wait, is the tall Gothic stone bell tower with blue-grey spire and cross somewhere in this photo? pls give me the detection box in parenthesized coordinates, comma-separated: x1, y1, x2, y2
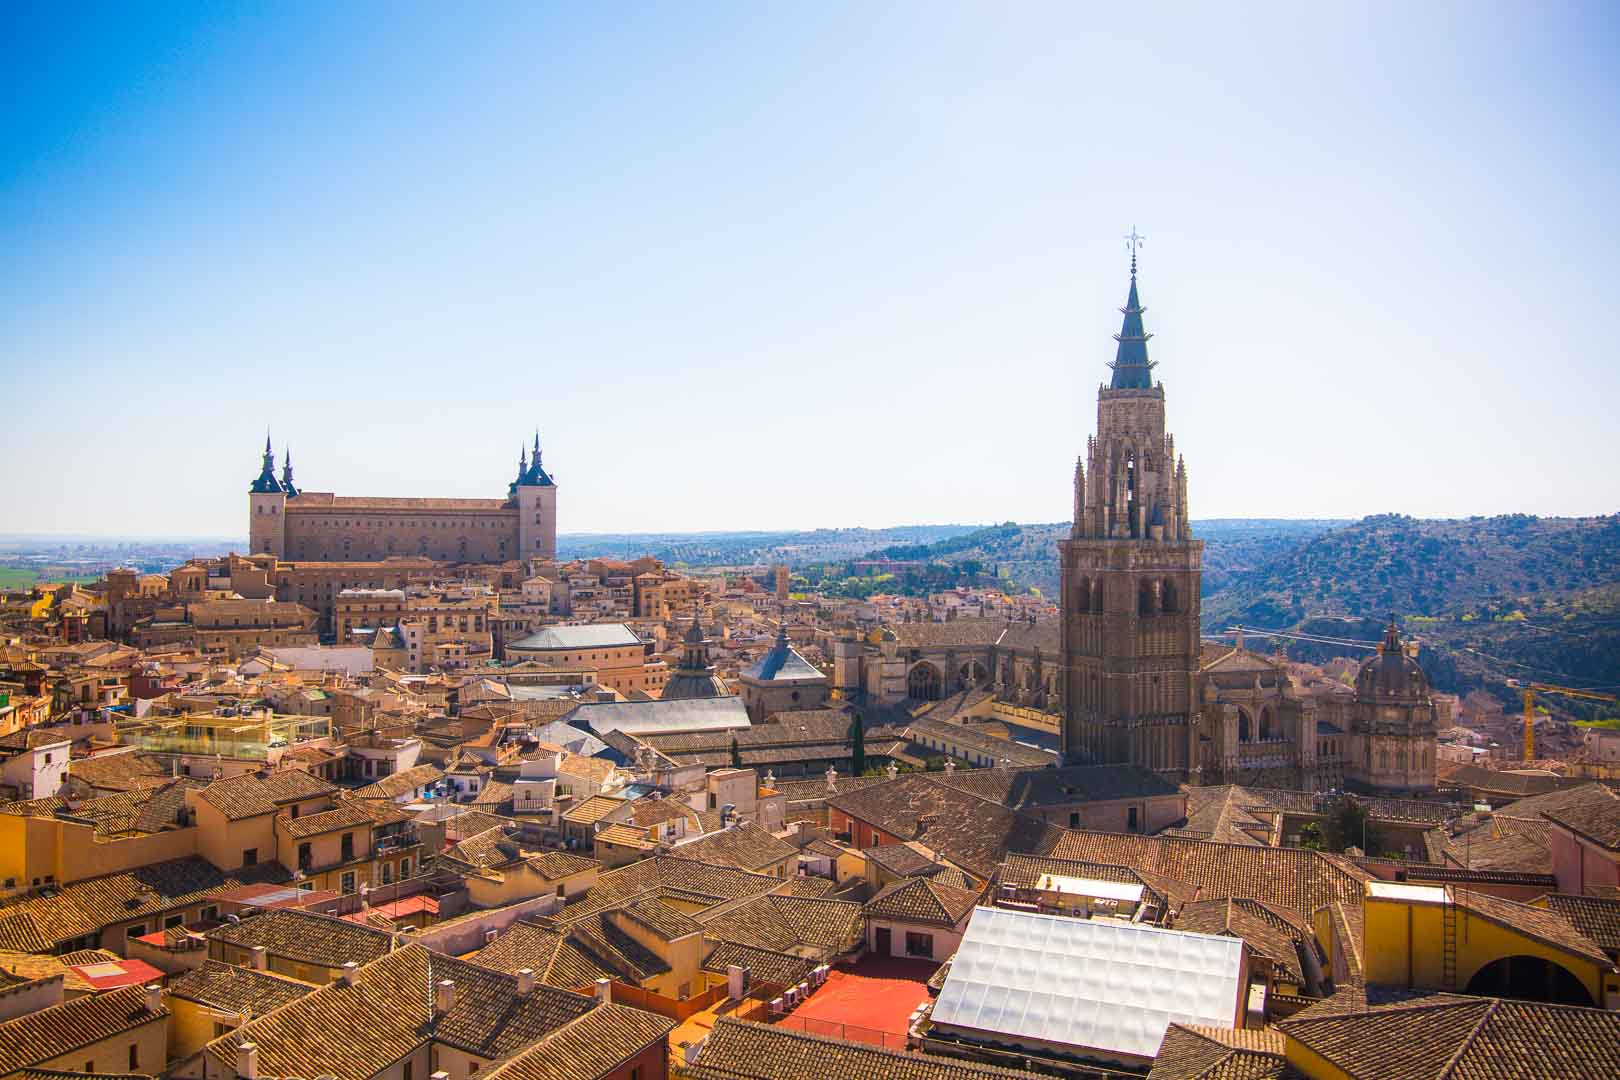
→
(1058, 249, 1204, 779)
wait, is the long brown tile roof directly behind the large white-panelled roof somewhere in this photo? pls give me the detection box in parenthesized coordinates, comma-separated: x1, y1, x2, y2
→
(1051, 829, 1367, 915)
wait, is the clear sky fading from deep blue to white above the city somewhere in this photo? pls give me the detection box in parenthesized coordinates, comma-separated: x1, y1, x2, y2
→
(0, 3, 1620, 534)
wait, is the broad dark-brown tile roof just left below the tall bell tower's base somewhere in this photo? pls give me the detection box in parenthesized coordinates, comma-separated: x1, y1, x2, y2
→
(828, 776, 1069, 879)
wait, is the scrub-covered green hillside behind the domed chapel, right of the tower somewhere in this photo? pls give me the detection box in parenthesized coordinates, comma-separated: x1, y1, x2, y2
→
(1204, 515, 1620, 716)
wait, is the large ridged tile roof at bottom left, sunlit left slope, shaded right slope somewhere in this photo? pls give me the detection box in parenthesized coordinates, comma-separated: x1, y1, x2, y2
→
(204, 944, 596, 1080)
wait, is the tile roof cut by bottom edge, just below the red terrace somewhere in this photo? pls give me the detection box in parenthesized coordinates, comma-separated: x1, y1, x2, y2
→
(693, 1016, 1037, 1080)
